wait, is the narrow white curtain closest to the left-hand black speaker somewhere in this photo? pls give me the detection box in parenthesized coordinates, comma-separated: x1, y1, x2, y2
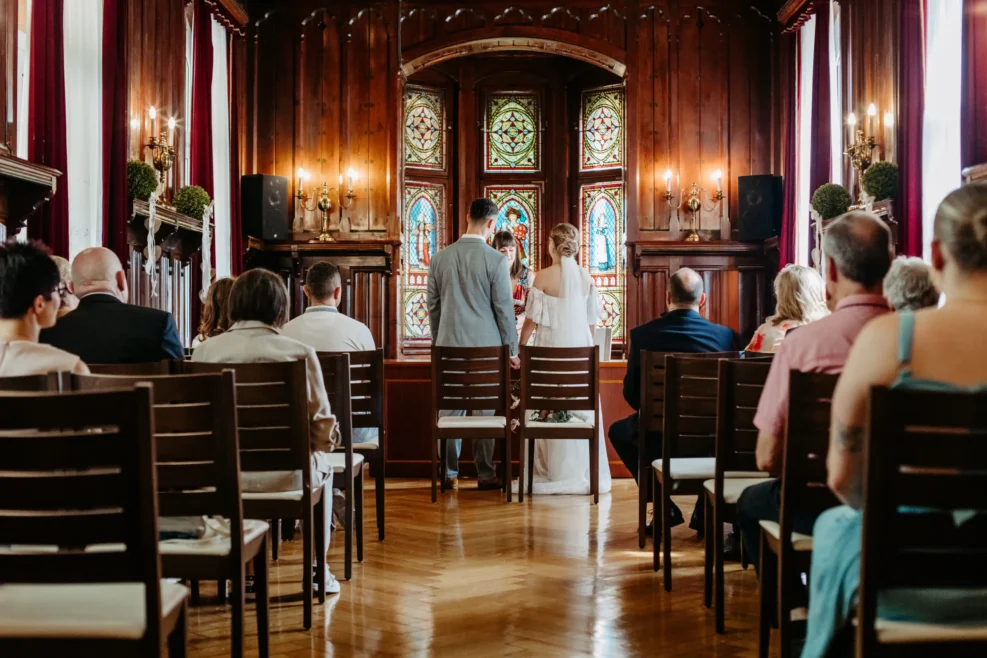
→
(212, 18, 231, 279)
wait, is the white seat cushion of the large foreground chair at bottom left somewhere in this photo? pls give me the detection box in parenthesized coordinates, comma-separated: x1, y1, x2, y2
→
(0, 581, 188, 640)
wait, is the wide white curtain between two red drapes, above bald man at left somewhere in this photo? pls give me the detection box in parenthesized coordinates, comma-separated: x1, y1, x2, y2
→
(64, 0, 103, 259)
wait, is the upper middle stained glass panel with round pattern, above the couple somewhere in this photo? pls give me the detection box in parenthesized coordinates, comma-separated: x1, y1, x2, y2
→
(483, 92, 541, 171)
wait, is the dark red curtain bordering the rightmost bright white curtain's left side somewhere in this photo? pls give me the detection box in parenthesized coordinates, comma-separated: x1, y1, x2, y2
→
(895, 0, 928, 256)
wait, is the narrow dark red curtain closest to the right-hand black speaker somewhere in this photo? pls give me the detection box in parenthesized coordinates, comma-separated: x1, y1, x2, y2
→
(778, 32, 800, 268)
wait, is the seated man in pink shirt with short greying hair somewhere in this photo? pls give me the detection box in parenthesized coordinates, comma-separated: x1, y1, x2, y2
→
(737, 211, 892, 568)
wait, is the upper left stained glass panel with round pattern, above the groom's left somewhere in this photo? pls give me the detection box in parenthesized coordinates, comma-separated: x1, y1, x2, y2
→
(404, 85, 445, 171)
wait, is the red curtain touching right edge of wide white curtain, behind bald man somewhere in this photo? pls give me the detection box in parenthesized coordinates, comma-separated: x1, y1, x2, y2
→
(103, 0, 130, 263)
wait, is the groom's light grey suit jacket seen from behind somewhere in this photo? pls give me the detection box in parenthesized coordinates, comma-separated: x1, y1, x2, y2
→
(428, 237, 518, 356)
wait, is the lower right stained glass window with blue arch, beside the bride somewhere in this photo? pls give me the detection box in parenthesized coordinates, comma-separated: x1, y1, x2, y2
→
(579, 183, 625, 342)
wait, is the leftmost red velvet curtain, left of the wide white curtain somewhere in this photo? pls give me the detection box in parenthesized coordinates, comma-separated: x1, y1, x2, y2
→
(26, 0, 69, 258)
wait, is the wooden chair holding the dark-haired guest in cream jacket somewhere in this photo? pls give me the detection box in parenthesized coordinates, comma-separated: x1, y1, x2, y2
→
(184, 361, 327, 630)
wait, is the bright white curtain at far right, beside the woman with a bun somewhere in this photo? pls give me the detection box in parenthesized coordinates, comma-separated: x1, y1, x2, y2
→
(922, 0, 963, 260)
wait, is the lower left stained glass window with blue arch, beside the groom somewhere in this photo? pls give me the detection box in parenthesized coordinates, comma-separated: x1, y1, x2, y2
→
(401, 181, 446, 342)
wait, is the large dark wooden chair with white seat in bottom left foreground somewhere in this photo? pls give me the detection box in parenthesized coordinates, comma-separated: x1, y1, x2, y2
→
(0, 385, 188, 658)
